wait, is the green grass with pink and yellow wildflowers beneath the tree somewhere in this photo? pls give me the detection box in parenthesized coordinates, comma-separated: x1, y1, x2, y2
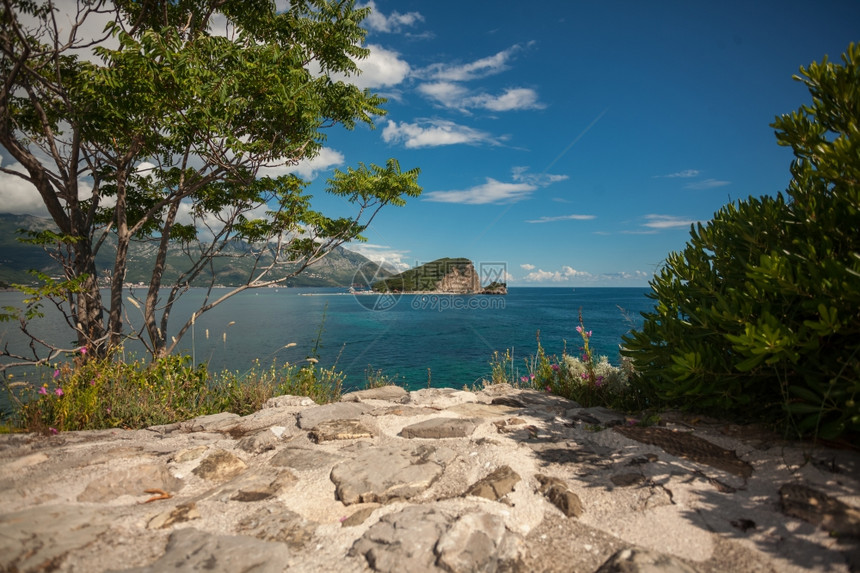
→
(0, 356, 344, 434)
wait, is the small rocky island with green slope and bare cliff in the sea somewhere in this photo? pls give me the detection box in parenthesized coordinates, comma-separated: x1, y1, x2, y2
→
(372, 258, 508, 295)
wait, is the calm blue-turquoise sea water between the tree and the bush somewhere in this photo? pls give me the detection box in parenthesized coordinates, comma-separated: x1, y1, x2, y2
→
(0, 287, 653, 394)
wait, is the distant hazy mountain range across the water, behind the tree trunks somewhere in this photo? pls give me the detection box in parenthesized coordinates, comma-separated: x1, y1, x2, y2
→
(0, 213, 396, 287)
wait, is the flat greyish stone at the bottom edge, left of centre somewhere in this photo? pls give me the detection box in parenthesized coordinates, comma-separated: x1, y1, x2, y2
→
(114, 527, 290, 573)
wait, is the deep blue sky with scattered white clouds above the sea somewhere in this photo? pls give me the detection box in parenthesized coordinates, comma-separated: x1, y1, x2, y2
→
(0, 0, 860, 287)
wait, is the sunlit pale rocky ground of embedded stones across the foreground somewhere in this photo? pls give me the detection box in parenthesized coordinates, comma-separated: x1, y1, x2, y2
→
(0, 385, 860, 573)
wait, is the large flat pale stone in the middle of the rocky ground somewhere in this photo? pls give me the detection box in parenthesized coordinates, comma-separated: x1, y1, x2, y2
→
(331, 444, 454, 505)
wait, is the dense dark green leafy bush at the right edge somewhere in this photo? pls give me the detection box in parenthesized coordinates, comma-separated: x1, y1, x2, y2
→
(622, 44, 860, 438)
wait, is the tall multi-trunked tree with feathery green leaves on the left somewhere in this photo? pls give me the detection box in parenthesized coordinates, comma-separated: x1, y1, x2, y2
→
(0, 0, 421, 366)
